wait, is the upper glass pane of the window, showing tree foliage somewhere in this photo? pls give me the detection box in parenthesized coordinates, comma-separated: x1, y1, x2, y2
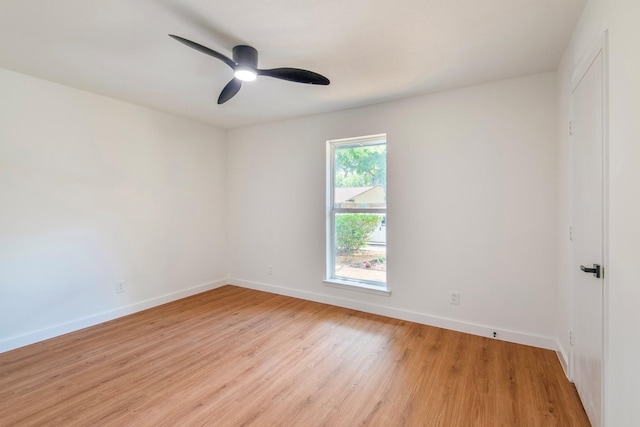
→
(333, 144, 387, 208)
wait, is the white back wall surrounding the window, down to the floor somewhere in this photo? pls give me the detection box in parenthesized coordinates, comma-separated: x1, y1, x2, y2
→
(228, 73, 558, 348)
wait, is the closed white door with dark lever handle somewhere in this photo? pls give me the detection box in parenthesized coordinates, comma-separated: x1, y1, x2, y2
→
(570, 45, 604, 427)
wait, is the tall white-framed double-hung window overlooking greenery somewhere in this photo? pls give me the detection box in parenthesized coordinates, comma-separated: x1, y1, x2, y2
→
(327, 135, 387, 291)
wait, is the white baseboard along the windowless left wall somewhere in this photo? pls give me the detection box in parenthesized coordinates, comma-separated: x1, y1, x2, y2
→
(0, 279, 228, 353)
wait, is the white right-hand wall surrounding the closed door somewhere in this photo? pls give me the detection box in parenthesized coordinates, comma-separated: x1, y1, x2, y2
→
(558, 0, 640, 426)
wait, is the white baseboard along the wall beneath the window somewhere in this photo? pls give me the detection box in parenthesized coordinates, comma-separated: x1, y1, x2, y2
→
(228, 277, 558, 351)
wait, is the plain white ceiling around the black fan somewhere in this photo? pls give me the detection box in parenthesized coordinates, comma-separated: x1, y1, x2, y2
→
(0, 0, 586, 129)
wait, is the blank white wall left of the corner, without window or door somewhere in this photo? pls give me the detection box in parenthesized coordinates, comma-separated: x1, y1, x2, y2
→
(0, 69, 227, 351)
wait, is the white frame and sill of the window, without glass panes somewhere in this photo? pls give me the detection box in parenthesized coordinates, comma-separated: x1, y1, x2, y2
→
(324, 134, 391, 296)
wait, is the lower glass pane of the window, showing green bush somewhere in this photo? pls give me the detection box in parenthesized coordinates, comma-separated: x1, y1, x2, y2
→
(334, 213, 387, 284)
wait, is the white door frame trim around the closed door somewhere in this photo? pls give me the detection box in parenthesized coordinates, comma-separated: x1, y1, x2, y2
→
(568, 30, 610, 426)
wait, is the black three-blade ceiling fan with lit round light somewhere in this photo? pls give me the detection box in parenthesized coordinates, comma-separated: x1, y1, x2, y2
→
(169, 34, 329, 104)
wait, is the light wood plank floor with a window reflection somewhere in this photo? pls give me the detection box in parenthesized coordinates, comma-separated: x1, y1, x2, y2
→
(0, 286, 589, 427)
